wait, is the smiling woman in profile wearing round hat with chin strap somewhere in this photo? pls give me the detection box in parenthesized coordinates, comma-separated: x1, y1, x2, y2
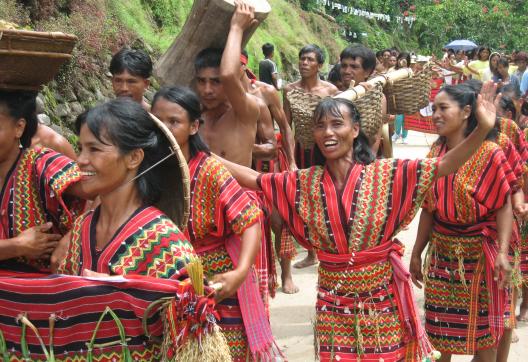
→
(53, 99, 194, 278)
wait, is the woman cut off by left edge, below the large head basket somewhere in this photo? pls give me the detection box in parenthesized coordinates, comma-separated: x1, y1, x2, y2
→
(0, 90, 87, 272)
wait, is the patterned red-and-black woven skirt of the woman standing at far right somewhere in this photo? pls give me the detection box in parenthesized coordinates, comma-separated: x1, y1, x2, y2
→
(424, 232, 512, 354)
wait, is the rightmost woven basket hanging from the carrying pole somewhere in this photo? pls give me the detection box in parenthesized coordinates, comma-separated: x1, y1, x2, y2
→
(384, 65, 433, 114)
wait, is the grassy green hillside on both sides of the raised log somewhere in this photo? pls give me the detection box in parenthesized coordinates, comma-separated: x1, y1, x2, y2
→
(108, 0, 346, 78)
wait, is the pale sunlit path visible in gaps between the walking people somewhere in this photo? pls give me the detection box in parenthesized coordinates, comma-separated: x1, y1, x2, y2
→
(271, 132, 528, 362)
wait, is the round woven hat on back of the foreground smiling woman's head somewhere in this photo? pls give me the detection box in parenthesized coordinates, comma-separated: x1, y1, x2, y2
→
(150, 114, 191, 230)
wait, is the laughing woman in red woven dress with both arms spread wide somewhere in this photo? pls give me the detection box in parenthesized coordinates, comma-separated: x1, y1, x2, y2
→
(218, 82, 495, 361)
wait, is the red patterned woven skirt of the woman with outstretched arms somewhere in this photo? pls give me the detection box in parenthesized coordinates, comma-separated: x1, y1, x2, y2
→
(315, 261, 417, 362)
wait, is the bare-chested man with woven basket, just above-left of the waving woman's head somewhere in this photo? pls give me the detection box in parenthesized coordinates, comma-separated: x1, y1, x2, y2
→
(283, 45, 339, 268)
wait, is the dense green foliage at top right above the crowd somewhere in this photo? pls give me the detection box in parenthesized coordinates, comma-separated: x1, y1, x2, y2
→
(299, 0, 528, 53)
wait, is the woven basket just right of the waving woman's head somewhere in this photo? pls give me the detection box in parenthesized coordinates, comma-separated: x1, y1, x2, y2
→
(354, 83, 383, 138)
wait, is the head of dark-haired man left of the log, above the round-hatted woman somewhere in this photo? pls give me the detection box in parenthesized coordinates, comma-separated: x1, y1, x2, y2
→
(110, 48, 152, 112)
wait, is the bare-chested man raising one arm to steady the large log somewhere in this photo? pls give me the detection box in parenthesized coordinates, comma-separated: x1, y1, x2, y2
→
(194, 3, 260, 167)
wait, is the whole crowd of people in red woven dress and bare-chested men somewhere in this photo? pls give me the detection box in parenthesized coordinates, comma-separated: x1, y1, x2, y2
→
(0, 2, 528, 362)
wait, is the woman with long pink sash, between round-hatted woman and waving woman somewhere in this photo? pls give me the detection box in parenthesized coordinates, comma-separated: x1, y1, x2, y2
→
(152, 86, 280, 361)
